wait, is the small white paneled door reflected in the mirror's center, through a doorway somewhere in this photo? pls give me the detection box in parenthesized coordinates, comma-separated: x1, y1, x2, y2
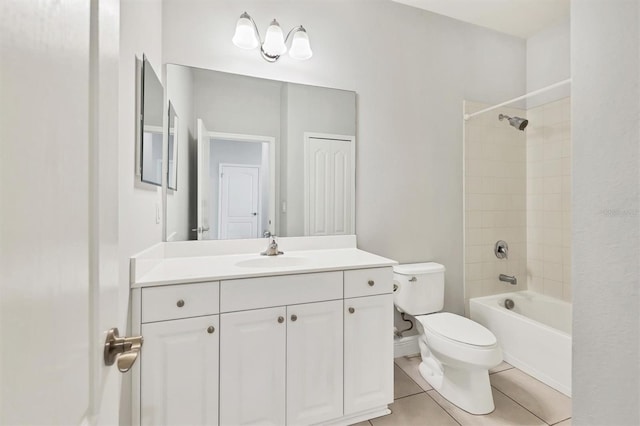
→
(219, 164, 260, 240)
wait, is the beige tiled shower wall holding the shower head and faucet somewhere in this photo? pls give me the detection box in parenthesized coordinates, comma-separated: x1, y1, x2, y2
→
(464, 102, 527, 307)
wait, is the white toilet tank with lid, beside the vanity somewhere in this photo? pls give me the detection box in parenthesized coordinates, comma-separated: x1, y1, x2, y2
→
(393, 262, 445, 316)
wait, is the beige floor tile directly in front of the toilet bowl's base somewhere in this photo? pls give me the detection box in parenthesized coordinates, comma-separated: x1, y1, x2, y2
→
(427, 389, 546, 426)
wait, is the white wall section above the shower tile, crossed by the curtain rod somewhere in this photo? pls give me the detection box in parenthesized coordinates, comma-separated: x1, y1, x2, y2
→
(527, 19, 571, 108)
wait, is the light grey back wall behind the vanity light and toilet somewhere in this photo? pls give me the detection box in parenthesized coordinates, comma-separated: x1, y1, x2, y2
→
(163, 0, 526, 313)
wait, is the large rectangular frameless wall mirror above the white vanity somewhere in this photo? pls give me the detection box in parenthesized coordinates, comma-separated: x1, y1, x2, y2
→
(165, 64, 356, 241)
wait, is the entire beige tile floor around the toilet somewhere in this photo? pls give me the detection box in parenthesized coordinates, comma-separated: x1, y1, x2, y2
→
(355, 355, 571, 426)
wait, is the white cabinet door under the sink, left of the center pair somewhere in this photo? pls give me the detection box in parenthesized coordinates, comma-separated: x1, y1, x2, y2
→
(220, 307, 287, 426)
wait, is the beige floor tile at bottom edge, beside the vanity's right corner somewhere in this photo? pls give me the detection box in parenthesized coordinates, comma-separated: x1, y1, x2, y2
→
(371, 392, 458, 426)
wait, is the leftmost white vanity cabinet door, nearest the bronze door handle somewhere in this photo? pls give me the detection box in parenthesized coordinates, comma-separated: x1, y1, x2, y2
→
(140, 315, 219, 426)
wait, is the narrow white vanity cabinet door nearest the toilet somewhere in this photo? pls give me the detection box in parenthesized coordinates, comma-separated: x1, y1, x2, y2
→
(344, 294, 393, 415)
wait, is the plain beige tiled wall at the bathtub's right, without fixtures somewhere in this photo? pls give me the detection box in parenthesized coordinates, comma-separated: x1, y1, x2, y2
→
(526, 98, 571, 301)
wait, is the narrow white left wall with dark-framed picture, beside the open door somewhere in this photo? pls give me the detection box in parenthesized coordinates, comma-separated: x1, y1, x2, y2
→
(120, 0, 163, 424)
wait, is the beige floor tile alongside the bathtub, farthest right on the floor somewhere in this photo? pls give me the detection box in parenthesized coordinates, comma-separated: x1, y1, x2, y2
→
(490, 368, 571, 424)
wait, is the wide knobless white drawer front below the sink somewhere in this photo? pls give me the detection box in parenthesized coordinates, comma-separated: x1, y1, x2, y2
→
(220, 272, 342, 312)
